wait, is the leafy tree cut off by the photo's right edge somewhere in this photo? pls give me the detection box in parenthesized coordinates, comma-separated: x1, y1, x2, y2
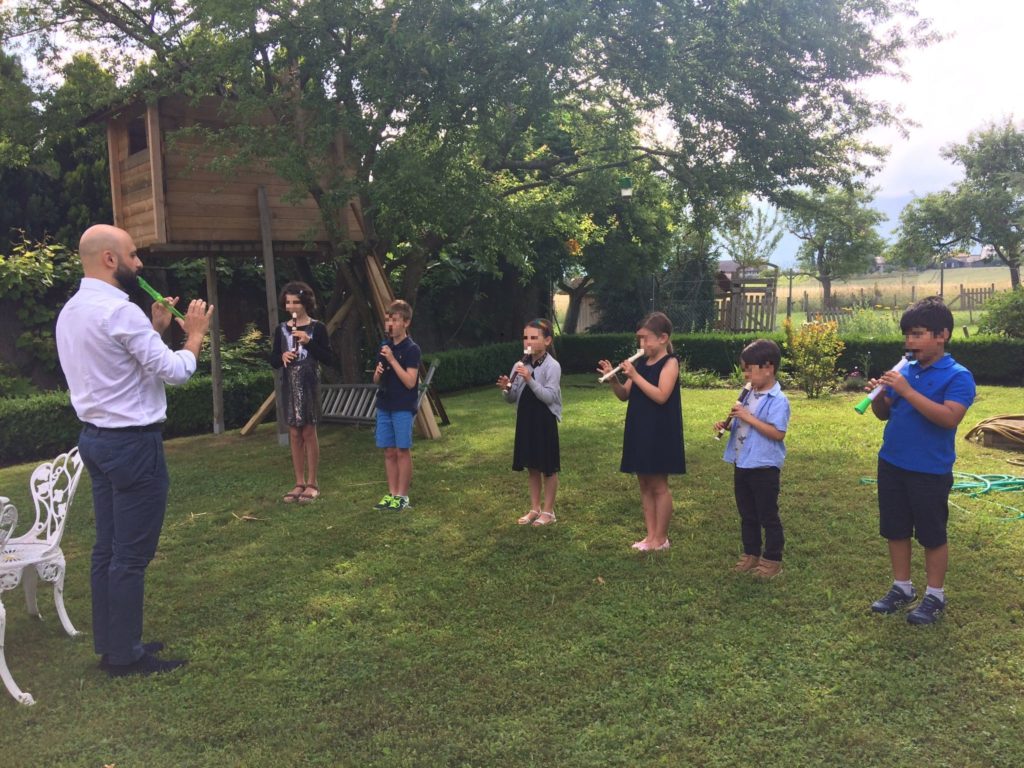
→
(897, 120, 1024, 289)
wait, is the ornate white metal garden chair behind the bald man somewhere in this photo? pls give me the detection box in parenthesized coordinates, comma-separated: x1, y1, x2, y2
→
(0, 447, 82, 705)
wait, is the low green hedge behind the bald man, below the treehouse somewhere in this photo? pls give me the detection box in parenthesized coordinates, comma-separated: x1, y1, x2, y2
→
(0, 371, 273, 466)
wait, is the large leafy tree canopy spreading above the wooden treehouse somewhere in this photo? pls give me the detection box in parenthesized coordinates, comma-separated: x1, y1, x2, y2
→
(0, 0, 924, 370)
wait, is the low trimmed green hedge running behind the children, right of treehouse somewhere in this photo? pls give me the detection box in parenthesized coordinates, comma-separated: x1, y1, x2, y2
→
(425, 333, 1024, 392)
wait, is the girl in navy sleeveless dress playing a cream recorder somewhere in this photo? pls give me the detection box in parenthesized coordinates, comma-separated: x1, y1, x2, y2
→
(597, 312, 686, 552)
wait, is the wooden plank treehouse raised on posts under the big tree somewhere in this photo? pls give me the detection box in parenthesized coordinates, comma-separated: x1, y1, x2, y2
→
(92, 96, 439, 442)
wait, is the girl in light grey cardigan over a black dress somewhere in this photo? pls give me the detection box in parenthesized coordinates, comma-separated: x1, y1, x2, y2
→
(497, 319, 562, 525)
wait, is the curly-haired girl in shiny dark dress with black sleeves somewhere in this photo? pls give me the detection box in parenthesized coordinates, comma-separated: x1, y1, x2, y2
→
(270, 282, 333, 503)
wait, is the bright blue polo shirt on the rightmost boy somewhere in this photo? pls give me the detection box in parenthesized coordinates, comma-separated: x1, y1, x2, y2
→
(879, 354, 975, 475)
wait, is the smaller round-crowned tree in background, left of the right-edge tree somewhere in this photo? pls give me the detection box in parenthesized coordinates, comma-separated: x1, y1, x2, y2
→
(786, 187, 886, 306)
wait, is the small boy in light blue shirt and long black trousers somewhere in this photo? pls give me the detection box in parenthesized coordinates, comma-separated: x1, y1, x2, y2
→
(715, 339, 790, 579)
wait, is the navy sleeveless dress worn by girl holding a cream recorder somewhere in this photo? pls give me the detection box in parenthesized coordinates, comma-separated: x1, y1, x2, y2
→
(620, 354, 686, 475)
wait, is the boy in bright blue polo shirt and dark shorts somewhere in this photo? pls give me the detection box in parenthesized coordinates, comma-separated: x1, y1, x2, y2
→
(868, 296, 975, 624)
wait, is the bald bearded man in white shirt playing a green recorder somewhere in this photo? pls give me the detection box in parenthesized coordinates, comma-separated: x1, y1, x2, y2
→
(56, 224, 213, 677)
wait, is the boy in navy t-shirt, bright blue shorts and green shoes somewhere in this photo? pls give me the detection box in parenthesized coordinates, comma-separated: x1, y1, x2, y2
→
(374, 299, 422, 510)
